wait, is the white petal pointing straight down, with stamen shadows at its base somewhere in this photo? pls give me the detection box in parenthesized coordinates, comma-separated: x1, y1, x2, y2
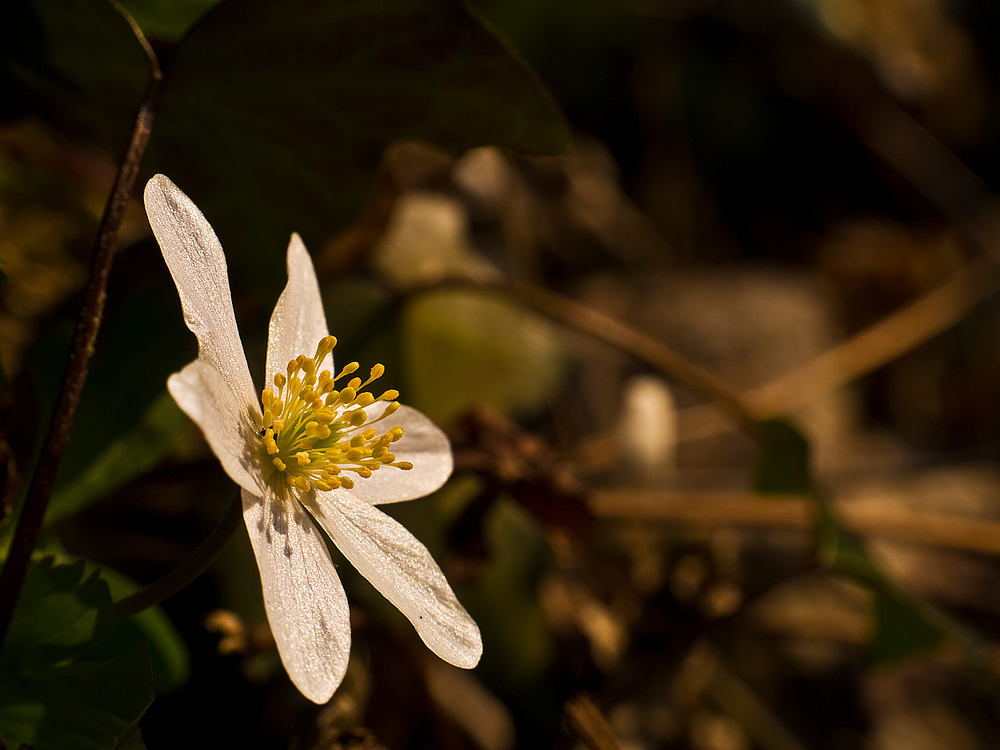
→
(243, 488, 351, 703)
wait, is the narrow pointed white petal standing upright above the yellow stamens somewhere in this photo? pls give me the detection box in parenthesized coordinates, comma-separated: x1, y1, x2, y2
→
(266, 234, 333, 385)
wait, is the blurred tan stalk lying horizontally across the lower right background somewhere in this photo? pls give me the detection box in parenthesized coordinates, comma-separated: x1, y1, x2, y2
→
(588, 490, 1000, 555)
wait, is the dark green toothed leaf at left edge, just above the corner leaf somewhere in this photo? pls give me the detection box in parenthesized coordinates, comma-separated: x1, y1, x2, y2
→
(0, 557, 115, 671)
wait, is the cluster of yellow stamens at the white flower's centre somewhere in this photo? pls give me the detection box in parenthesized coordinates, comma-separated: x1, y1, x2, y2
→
(260, 336, 413, 492)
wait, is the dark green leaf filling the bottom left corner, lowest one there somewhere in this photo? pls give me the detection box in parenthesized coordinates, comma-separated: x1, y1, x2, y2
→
(0, 644, 153, 750)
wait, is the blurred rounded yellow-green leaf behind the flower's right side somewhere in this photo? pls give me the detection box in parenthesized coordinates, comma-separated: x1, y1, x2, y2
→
(403, 290, 563, 421)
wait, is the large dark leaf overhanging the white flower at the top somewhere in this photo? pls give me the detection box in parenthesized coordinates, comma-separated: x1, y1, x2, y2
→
(148, 0, 569, 270)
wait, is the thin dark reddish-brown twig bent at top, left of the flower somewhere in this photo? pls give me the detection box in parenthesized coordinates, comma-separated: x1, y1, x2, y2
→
(0, 5, 163, 644)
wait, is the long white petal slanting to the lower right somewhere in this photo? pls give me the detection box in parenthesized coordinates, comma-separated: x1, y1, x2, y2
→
(302, 492, 483, 669)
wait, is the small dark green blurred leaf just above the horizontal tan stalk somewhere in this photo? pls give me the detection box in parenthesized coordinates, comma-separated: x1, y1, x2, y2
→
(753, 419, 812, 495)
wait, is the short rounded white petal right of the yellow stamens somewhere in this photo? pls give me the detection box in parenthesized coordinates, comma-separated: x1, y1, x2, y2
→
(334, 403, 452, 505)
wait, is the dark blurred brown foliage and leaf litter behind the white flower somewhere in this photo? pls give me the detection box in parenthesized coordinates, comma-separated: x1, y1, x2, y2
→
(0, 0, 1000, 750)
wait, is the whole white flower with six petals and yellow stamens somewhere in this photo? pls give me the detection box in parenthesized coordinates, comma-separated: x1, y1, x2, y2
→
(145, 175, 483, 703)
